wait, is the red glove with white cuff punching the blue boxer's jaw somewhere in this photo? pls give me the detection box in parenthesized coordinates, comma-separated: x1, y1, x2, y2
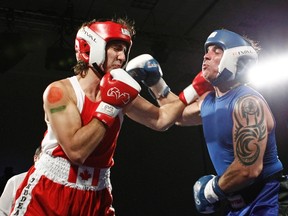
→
(179, 71, 214, 105)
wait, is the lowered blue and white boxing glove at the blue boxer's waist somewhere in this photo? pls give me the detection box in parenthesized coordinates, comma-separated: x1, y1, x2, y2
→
(193, 175, 226, 214)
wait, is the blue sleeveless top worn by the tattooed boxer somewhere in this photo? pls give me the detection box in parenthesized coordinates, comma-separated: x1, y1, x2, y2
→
(201, 85, 283, 178)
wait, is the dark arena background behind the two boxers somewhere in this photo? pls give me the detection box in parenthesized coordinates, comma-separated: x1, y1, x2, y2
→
(0, 0, 288, 216)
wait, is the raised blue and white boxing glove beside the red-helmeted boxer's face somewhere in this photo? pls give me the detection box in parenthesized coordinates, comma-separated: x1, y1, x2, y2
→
(126, 54, 170, 99)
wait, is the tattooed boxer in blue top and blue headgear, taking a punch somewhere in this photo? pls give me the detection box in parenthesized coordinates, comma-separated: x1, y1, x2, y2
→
(127, 29, 288, 216)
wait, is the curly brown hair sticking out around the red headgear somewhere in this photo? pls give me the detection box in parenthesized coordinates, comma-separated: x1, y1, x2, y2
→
(73, 17, 136, 78)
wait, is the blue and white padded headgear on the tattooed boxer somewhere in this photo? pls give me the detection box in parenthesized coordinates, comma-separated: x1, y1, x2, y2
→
(204, 29, 258, 86)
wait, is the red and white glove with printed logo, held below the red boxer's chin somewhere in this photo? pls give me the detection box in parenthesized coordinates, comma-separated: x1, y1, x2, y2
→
(93, 69, 141, 127)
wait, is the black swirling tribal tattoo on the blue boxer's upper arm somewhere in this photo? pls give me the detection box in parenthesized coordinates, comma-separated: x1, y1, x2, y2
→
(233, 96, 267, 166)
